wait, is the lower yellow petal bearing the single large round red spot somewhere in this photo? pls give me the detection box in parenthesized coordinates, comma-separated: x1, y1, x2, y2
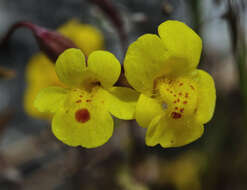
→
(52, 87, 113, 148)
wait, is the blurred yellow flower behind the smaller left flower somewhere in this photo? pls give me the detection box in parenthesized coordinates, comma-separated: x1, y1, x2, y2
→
(24, 19, 104, 119)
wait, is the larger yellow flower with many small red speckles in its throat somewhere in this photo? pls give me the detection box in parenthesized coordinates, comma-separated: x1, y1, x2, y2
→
(124, 21, 216, 147)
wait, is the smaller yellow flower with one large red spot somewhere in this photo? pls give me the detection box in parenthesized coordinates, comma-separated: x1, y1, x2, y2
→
(34, 48, 138, 148)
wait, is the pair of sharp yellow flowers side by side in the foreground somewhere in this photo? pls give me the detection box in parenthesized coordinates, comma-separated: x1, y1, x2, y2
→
(27, 21, 216, 148)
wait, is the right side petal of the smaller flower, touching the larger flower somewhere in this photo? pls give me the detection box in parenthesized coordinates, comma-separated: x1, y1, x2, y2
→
(101, 87, 139, 120)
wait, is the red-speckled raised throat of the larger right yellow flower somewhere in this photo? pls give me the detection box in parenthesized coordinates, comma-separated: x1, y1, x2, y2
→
(156, 77, 197, 120)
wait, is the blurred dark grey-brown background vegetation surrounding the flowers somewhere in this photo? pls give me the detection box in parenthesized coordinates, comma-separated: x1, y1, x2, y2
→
(0, 0, 247, 190)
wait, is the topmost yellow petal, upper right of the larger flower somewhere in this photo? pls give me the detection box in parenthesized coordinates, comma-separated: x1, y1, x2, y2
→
(158, 20, 202, 74)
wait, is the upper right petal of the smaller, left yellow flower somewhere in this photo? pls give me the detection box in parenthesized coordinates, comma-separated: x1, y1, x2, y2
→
(88, 50, 121, 88)
